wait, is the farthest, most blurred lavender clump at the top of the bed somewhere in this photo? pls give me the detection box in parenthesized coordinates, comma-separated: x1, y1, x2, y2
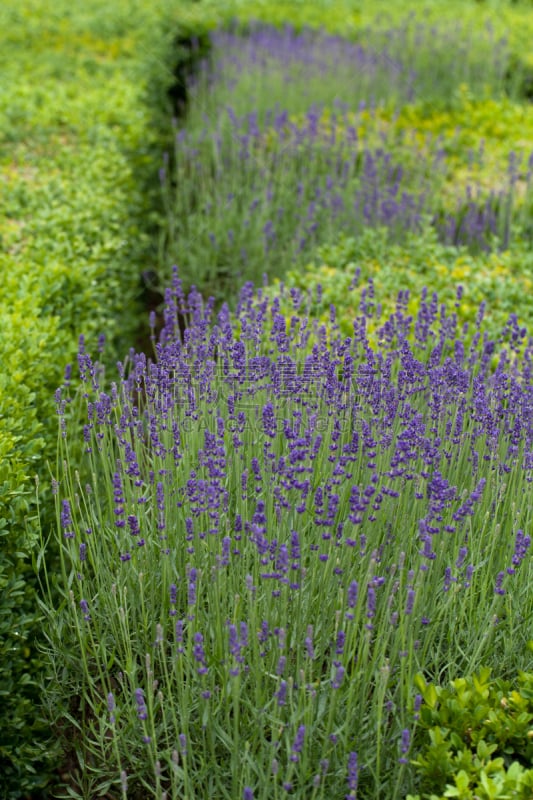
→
(185, 20, 509, 129)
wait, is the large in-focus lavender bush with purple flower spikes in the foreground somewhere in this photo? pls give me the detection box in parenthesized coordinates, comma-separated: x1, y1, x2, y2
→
(43, 274, 533, 800)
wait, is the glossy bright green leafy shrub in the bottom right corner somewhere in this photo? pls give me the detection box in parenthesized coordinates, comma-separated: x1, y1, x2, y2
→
(408, 669, 533, 800)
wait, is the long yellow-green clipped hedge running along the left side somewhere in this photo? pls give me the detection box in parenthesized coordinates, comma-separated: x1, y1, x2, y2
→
(0, 0, 216, 798)
